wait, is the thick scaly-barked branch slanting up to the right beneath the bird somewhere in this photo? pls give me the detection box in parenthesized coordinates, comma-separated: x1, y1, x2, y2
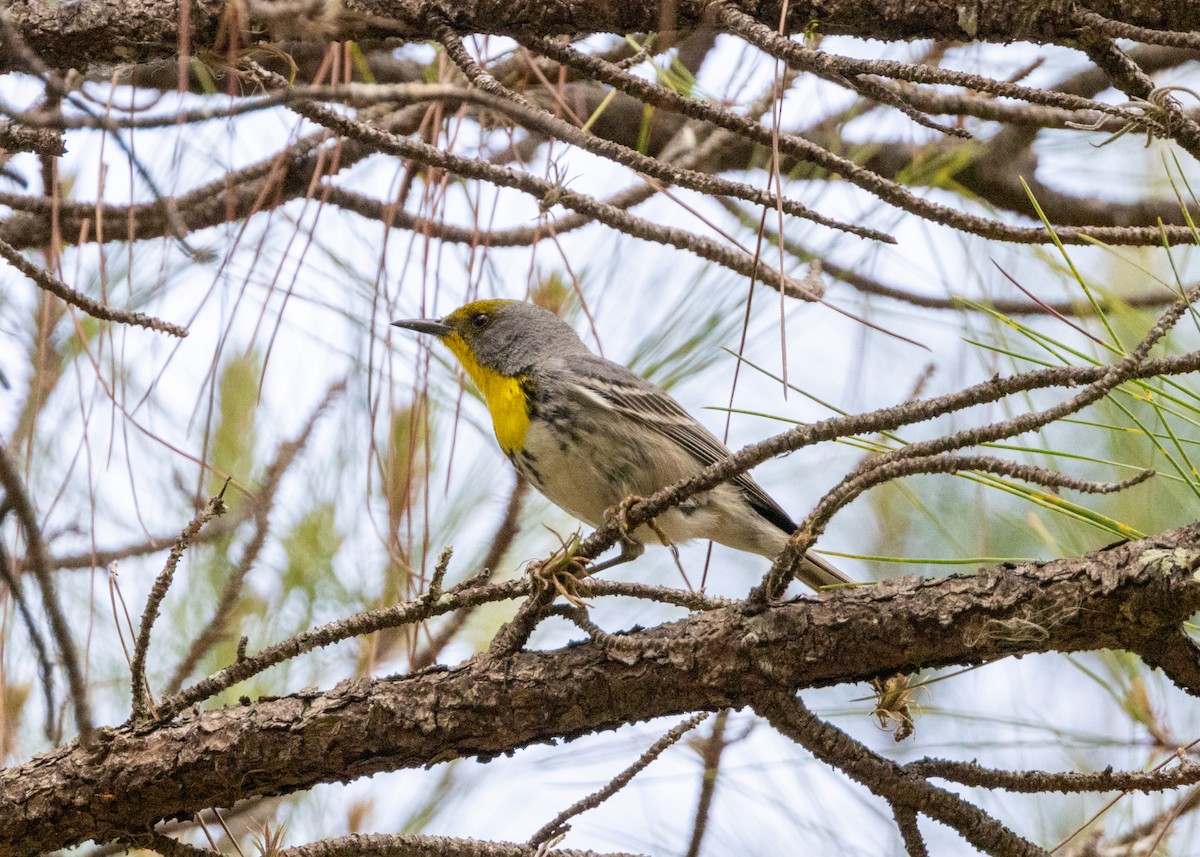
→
(7, 525, 1200, 855)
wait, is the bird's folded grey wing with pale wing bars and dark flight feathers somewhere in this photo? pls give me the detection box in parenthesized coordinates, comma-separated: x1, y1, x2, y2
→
(572, 355, 796, 534)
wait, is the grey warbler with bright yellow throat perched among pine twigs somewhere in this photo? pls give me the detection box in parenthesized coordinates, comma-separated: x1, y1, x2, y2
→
(392, 300, 853, 588)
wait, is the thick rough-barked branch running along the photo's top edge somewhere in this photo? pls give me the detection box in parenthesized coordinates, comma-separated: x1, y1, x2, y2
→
(7, 0, 1200, 71)
